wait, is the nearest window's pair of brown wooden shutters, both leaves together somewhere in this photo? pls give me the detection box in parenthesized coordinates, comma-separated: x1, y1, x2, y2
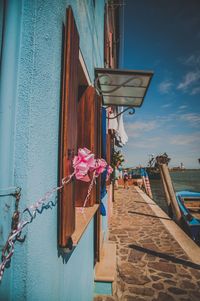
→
(58, 8, 101, 247)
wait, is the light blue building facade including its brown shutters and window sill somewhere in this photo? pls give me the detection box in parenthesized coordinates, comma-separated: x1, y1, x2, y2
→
(0, 0, 120, 301)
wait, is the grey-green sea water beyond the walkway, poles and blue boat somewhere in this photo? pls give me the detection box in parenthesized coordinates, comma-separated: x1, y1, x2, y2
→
(150, 169, 200, 213)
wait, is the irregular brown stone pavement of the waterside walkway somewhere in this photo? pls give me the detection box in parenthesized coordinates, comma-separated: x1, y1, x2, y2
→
(94, 187, 200, 301)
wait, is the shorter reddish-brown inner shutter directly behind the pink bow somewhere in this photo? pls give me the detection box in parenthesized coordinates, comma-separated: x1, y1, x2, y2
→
(76, 86, 100, 206)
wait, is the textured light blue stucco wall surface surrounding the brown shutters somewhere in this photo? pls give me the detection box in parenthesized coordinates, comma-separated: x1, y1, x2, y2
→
(0, 0, 104, 301)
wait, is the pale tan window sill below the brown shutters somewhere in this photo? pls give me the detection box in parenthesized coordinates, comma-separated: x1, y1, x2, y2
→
(72, 204, 99, 247)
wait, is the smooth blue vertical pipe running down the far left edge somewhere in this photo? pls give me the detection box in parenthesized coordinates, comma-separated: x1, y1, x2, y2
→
(0, 1, 22, 300)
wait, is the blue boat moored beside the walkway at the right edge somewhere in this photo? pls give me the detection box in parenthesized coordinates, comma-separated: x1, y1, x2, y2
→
(176, 191, 200, 244)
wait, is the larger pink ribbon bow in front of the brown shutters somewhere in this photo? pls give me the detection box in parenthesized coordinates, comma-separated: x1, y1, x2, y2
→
(73, 147, 95, 182)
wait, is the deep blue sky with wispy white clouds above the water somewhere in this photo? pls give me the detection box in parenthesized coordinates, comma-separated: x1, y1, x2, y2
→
(120, 0, 200, 168)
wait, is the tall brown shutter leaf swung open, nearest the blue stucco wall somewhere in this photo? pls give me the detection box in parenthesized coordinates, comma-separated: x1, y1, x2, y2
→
(59, 7, 79, 247)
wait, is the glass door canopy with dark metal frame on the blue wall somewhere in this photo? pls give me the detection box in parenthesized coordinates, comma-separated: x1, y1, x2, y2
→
(95, 68, 153, 107)
